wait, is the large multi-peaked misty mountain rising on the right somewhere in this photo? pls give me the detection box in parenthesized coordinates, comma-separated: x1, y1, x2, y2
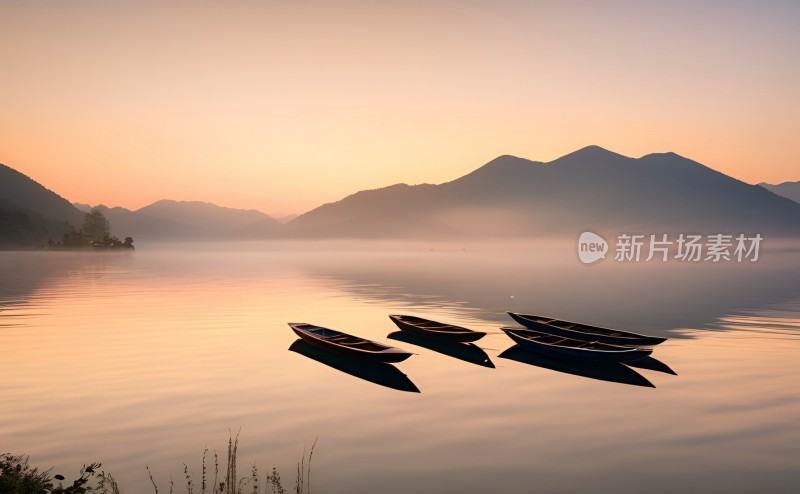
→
(287, 146, 800, 238)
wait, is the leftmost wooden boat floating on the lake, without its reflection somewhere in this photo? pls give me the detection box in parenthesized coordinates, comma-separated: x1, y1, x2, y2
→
(289, 322, 413, 362)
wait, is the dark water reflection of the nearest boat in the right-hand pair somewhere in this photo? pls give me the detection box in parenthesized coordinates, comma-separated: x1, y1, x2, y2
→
(499, 345, 655, 388)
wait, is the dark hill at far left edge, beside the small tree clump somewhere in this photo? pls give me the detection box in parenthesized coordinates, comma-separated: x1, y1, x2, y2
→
(0, 164, 83, 249)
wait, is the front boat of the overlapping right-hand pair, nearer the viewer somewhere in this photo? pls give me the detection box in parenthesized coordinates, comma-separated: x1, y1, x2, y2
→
(501, 328, 653, 362)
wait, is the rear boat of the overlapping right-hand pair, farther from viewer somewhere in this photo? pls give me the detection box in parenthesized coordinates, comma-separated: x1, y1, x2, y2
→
(508, 312, 667, 346)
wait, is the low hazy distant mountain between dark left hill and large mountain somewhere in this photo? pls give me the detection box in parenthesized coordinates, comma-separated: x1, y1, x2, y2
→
(80, 200, 283, 241)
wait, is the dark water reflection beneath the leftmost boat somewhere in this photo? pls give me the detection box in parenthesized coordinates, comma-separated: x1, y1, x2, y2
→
(289, 339, 420, 393)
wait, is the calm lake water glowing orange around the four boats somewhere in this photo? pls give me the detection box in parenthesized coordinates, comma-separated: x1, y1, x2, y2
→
(0, 243, 800, 493)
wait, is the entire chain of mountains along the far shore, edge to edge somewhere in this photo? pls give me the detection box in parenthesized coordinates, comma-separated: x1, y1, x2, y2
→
(0, 146, 800, 248)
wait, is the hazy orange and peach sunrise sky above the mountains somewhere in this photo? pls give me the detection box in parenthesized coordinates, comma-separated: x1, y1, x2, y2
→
(0, 0, 800, 214)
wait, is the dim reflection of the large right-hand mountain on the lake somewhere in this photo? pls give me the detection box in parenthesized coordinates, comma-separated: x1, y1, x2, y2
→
(300, 249, 800, 337)
